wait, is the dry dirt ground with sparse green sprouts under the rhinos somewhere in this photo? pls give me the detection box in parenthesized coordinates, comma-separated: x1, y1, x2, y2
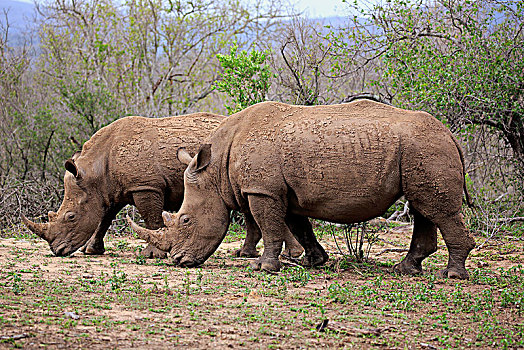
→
(0, 226, 524, 349)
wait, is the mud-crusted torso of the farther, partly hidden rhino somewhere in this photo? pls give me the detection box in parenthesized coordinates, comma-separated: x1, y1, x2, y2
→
(81, 113, 224, 197)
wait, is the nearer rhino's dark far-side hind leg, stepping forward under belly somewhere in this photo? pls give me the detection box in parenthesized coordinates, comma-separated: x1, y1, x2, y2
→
(393, 208, 437, 275)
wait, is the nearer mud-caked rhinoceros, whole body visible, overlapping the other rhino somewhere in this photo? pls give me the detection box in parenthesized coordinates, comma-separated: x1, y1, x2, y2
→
(129, 100, 475, 279)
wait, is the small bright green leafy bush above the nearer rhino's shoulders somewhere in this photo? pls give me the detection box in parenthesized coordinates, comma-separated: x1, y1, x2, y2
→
(215, 43, 273, 114)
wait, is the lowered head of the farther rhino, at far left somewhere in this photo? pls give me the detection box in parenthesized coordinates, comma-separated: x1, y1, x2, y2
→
(22, 154, 105, 256)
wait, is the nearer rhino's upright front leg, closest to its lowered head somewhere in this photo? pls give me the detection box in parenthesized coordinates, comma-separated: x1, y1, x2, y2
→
(248, 195, 289, 271)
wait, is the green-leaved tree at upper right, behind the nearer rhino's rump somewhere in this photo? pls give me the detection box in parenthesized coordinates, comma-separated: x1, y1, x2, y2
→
(338, 0, 524, 167)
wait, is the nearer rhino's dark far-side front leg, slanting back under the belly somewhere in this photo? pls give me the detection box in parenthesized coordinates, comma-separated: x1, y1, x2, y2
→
(286, 214, 328, 267)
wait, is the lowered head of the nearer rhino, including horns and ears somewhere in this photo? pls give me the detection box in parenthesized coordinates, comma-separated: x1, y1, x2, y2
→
(128, 145, 229, 267)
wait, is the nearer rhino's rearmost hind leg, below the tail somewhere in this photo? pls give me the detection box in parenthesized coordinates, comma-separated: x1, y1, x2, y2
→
(437, 213, 475, 279)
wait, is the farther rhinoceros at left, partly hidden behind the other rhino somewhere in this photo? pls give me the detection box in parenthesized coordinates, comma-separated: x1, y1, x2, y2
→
(22, 113, 303, 257)
